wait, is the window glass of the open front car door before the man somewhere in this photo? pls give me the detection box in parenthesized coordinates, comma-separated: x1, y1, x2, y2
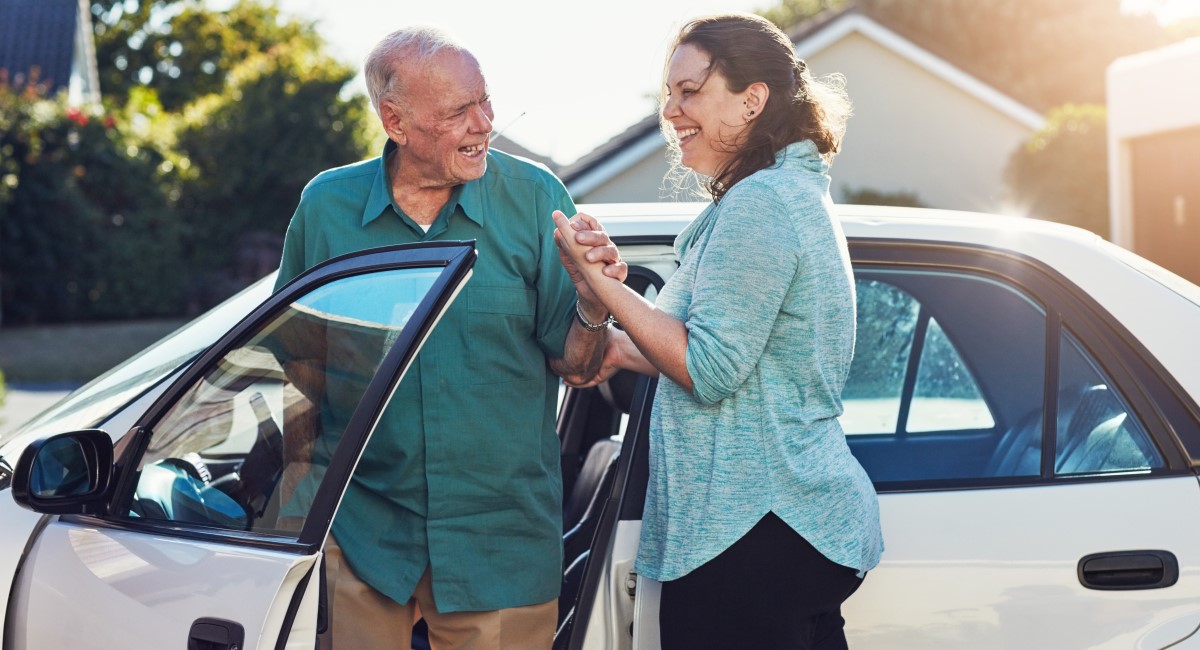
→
(128, 269, 439, 534)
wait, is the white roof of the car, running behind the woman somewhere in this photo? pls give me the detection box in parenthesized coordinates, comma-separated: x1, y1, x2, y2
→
(578, 203, 1200, 403)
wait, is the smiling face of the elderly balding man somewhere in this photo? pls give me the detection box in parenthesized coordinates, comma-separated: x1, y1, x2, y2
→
(384, 50, 494, 187)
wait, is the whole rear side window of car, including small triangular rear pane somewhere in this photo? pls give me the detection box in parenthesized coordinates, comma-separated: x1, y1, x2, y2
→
(840, 267, 1166, 487)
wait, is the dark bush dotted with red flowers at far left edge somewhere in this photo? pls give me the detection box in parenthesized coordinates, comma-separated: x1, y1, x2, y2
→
(0, 76, 186, 324)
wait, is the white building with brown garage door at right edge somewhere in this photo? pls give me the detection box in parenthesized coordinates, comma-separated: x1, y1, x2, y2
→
(1108, 38, 1200, 284)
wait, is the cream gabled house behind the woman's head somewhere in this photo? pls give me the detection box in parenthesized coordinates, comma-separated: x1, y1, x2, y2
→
(559, 7, 1044, 211)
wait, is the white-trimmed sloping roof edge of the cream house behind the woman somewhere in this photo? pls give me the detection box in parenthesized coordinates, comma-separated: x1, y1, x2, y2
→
(559, 5, 1045, 195)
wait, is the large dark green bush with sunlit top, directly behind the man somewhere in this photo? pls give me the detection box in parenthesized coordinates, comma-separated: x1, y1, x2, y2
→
(176, 41, 371, 308)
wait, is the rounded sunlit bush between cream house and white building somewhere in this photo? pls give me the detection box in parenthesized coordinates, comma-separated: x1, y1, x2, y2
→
(1006, 104, 1109, 237)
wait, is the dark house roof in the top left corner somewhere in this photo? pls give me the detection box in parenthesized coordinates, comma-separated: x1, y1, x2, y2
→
(0, 0, 79, 91)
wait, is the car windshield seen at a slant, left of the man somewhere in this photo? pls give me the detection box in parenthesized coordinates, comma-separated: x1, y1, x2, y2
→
(0, 273, 275, 447)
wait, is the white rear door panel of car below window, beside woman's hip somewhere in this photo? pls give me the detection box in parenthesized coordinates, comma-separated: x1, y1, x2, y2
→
(844, 476, 1200, 650)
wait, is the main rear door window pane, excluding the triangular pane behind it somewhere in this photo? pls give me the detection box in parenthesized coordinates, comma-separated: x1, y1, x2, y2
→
(841, 269, 1046, 482)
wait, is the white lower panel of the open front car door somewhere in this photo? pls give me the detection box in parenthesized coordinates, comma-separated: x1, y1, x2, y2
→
(10, 523, 319, 649)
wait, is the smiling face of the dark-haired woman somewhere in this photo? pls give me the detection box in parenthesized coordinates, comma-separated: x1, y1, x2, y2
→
(662, 44, 750, 176)
